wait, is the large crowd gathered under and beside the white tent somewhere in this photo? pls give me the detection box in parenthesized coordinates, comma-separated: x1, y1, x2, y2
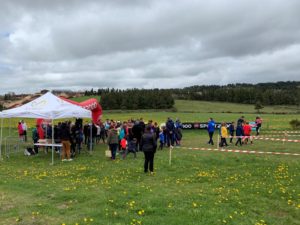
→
(22, 118, 182, 172)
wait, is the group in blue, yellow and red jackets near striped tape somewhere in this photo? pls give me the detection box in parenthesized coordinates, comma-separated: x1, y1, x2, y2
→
(207, 116, 262, 147)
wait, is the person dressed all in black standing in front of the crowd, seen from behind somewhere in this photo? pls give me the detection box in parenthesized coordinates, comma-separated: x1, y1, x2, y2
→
(141, 126, 157, 174)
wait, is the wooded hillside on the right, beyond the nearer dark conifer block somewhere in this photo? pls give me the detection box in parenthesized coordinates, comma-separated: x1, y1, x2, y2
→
(173, 81, 300, 105)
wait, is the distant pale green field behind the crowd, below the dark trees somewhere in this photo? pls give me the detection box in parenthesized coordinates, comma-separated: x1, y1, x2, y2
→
(4, 100, 300, 129)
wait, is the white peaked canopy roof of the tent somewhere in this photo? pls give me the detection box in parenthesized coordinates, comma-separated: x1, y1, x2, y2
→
(0, 92, 91, 119)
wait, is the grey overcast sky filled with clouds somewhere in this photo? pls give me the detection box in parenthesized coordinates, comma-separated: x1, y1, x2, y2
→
(0, 0, 300, 94)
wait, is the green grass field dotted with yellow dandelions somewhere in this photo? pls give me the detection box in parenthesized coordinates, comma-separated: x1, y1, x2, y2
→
(0, 101, 300, 225)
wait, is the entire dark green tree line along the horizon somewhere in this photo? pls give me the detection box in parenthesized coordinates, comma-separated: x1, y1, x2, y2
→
(84, 81, 300, 110)
